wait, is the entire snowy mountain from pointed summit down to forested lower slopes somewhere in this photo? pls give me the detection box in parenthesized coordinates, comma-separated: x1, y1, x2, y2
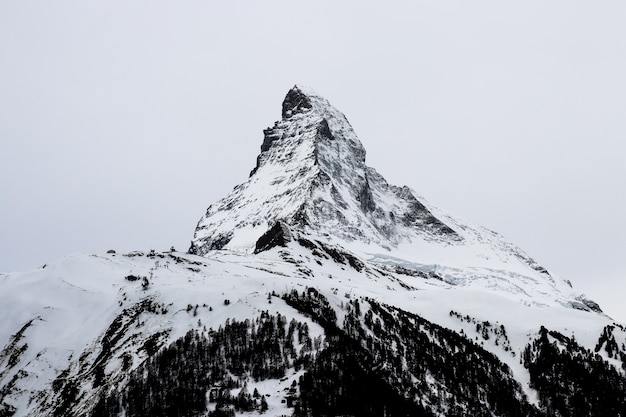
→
(0, 86, 626, 417)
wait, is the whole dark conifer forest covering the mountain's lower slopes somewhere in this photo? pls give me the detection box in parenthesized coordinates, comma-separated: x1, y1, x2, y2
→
(92, 288, 626, 417)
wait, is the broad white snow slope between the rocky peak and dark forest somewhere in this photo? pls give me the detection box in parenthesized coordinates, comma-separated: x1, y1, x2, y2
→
(0, 242, 626, 415)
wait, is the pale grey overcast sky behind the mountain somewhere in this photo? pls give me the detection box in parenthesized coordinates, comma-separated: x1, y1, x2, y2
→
(0, 0, 626, 322)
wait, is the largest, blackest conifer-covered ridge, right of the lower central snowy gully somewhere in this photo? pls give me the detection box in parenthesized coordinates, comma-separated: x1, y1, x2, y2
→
(285, 288, 541, 417)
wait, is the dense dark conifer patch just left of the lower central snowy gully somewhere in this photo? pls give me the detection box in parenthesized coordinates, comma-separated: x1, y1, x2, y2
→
(93, 313, 310, 417)
